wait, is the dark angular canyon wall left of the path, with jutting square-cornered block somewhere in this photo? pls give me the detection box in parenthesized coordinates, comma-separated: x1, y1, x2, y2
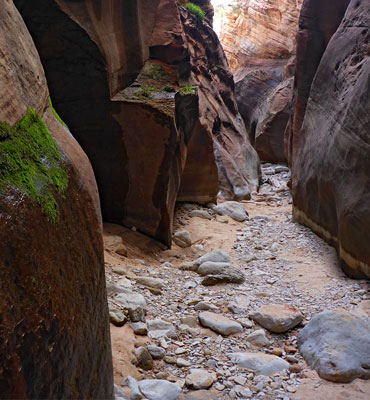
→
(15, 0, 259, 246)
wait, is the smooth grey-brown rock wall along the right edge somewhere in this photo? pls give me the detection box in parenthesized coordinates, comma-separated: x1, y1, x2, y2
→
(292, 1, 370, 278)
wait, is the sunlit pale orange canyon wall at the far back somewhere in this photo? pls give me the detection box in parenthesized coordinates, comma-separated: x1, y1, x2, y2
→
(220, 0, 303, 162)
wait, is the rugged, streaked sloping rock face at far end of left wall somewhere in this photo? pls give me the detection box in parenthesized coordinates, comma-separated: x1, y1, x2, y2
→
(181, 6, 259, 200)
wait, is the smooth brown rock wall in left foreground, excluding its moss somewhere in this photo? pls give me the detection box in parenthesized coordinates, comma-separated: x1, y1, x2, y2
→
(0, 1, 113, 399)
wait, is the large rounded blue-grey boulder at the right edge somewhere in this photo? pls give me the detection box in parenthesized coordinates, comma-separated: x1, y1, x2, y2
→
(298, 311, 370, 383)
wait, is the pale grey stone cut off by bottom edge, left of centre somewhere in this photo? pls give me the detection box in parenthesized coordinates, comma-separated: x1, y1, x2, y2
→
(138, 379, 181, 400)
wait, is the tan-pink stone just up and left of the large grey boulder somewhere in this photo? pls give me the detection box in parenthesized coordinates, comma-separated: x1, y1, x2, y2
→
(250, 304, 303, 333)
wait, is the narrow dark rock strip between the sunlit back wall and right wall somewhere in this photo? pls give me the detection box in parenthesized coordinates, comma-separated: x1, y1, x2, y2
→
(285, 0, 350, 163)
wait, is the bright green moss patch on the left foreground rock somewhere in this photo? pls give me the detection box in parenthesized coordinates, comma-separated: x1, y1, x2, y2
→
(0, 108, 69, 223)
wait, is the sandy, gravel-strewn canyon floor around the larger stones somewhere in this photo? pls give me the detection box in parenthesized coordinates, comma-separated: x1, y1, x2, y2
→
(104, 164, 370, 400)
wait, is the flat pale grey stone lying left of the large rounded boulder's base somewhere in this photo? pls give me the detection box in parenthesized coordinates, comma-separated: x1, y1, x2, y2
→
(230, 353, 289, 376)
